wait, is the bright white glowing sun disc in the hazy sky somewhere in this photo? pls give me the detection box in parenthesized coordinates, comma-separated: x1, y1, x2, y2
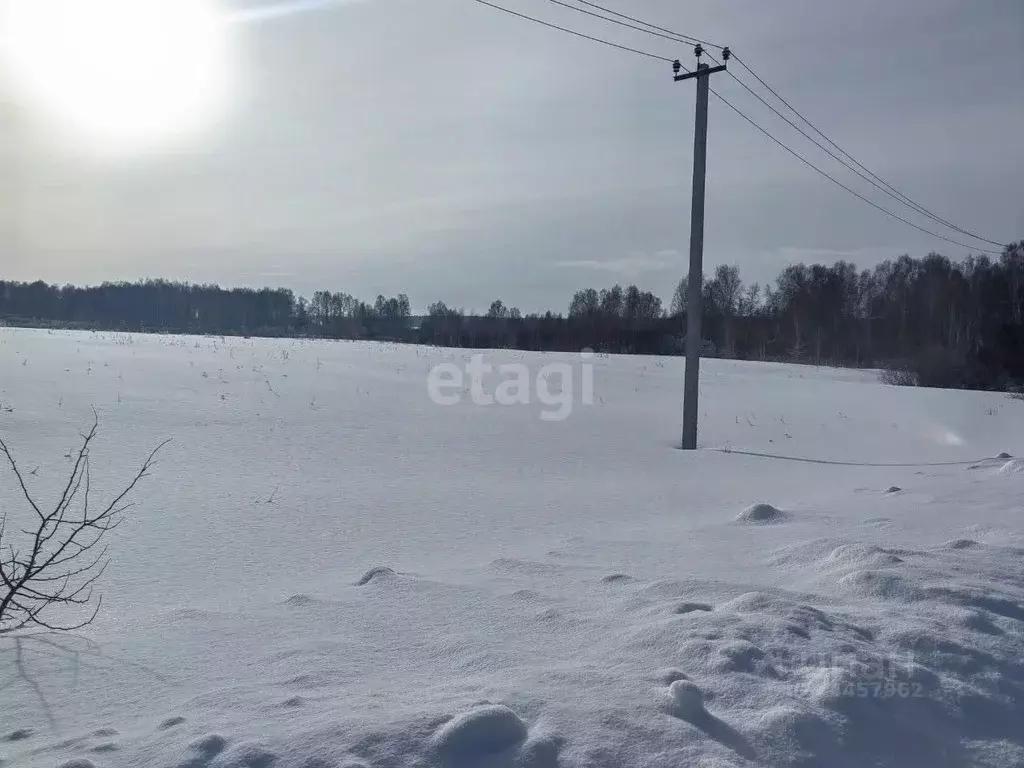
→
(0, 0, 228, 150)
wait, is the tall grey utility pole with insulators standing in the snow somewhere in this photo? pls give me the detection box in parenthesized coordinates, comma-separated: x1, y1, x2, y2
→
(674, 45, 729, 451)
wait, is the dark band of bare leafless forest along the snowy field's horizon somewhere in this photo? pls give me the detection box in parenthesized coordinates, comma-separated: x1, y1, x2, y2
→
(0, 241, 1024, 390)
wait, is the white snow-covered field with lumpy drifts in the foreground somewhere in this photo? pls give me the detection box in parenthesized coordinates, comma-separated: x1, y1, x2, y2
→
(0, 329, 1024, 768)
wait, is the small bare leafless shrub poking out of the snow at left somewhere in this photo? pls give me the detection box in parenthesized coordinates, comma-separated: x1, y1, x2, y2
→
(0, 416, 170, 634)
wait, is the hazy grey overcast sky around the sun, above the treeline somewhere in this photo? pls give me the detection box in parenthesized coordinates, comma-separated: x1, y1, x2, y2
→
(0, 0, 1024, 311)
